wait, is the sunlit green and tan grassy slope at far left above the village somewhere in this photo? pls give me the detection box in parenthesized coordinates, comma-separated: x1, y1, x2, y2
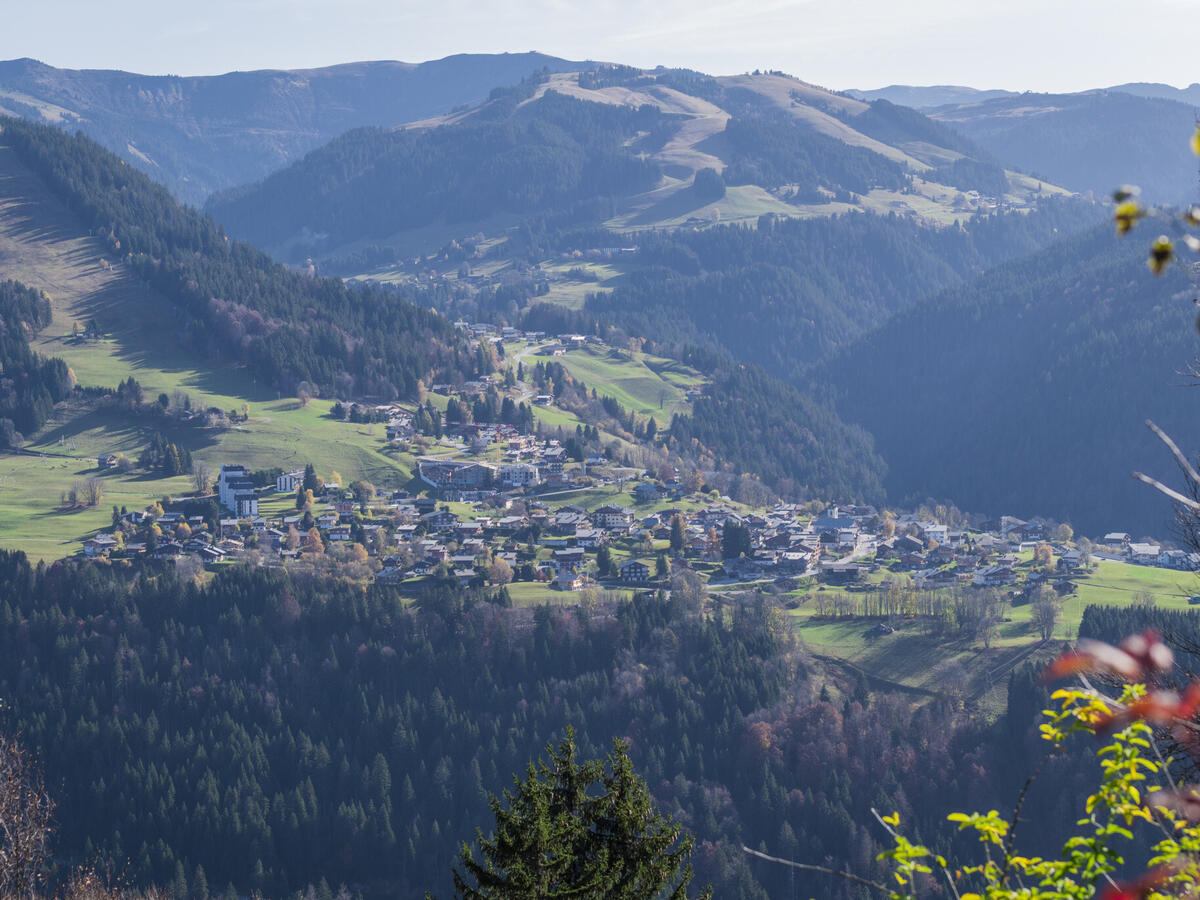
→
(0, 146, 414, 559)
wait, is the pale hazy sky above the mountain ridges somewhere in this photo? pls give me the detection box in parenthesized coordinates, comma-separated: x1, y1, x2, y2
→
(9, 0, 1200, 91)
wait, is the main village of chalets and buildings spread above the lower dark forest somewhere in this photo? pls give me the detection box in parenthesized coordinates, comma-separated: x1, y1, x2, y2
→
(84, 465, 1200, 607)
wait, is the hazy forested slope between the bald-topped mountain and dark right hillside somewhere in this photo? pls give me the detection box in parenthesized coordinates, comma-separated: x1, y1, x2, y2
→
(584, 200, 1102, 378)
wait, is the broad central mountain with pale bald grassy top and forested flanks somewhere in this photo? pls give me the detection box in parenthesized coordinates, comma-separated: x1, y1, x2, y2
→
(208, 66, 1061, 259)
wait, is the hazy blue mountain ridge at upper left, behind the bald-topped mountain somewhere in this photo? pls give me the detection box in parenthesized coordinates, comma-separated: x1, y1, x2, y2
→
(0, 53, 589, 204)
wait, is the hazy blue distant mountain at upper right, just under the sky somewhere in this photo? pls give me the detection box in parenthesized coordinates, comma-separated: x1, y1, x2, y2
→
(926, 85, 1196, 203)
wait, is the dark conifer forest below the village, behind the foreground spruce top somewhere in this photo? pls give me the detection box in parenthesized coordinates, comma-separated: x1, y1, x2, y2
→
(0, 552, 1088, 899)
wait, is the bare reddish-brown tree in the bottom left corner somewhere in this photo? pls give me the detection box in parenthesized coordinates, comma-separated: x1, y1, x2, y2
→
(0, 736, 54, 898)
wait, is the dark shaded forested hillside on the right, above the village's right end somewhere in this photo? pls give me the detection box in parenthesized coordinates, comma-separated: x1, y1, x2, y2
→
(816, 227, 1200, 534)
